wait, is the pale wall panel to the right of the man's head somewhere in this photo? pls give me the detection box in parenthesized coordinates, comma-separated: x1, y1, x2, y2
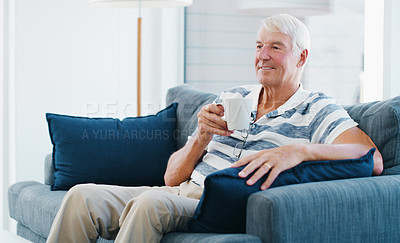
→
(303, 0, 364, 104)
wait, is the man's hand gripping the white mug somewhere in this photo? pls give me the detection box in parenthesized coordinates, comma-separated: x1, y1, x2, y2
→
(197, 104, 233, 144)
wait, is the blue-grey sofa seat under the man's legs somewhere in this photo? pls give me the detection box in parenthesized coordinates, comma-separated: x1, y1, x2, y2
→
(9, 181, 261, 243)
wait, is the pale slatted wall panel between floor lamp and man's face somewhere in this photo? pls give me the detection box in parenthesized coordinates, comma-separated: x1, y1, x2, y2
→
(185, 0, 263, 93)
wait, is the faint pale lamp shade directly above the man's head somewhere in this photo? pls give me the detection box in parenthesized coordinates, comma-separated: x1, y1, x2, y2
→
(236, 0, 330, 17)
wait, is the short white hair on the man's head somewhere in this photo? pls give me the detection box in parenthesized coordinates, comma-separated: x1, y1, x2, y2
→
(262, 14, 310, 55)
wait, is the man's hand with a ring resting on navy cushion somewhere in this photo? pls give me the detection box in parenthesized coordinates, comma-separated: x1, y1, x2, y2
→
(232, 144, 305, 190)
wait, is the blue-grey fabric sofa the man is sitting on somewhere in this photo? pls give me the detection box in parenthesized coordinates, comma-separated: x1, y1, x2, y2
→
(8, 85, 400, 243)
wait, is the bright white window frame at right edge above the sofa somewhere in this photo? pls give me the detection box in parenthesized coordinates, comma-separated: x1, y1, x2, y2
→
(361, 0, 400, 102)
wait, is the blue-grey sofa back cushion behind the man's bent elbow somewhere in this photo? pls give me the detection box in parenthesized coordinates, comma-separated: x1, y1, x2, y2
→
(345, 96, 400, 175)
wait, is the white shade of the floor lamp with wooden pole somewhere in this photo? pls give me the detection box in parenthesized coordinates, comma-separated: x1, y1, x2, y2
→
(89, 0, 193, 8)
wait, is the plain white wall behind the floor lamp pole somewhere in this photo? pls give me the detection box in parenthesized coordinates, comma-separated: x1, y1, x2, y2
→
(2, 0, 184, 230)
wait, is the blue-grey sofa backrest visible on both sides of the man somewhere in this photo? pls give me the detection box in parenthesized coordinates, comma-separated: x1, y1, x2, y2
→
(167, 85, 400, 175)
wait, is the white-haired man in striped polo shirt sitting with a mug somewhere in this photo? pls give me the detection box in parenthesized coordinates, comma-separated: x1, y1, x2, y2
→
(48, 14, 383, 242)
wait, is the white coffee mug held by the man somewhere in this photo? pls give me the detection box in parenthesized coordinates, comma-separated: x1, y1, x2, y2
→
(221, 98, 253, 130)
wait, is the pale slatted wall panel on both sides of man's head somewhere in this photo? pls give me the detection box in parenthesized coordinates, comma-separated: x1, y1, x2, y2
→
(185, 0, 364, 104)
